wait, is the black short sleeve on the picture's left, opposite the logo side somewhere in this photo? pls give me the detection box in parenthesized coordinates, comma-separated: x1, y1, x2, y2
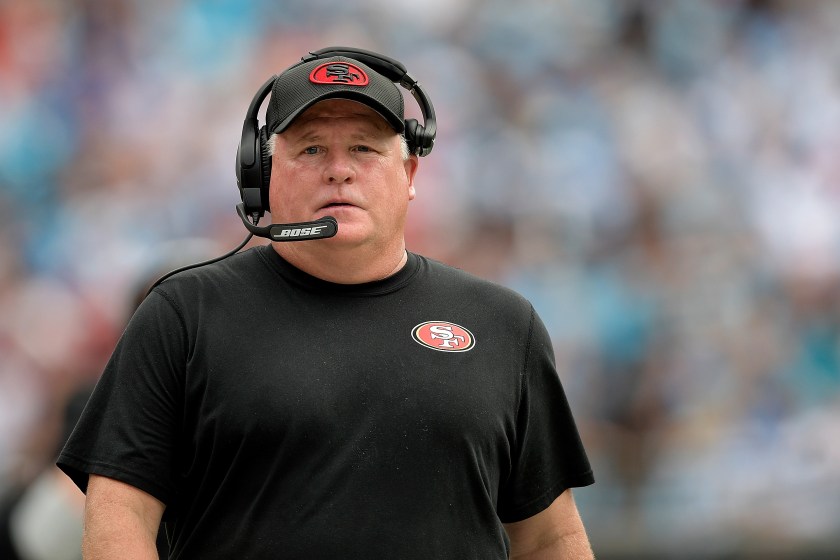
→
(57, 292, 188, 504)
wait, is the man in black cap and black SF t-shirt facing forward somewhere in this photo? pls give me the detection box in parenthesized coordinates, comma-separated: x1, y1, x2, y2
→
(59, 49, 593, 560)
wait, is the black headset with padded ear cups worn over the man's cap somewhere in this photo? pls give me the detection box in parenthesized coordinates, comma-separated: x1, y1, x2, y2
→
(236, 47, 437, 221)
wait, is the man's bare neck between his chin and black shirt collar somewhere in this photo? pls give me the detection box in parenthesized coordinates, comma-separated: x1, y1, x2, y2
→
(272, 240, 408, 284)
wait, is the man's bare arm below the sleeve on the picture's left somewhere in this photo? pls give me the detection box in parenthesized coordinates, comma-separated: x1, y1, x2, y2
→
(82, 475, 165, 560)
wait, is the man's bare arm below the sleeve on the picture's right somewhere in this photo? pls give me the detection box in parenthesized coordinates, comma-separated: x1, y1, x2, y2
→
(505, 490, 594, 560)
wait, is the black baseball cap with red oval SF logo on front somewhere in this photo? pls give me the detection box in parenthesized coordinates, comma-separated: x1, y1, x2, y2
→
(266, 56, 405, 134)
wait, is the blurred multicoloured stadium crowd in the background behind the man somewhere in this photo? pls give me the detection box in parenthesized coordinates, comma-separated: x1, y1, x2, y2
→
(0, 0, 840, 558)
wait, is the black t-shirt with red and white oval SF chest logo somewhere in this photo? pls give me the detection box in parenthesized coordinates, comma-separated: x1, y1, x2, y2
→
(58, 245, 593, 560)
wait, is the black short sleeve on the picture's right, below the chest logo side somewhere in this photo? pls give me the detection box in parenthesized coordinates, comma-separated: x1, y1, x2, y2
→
(498, 308, 595, 523)
